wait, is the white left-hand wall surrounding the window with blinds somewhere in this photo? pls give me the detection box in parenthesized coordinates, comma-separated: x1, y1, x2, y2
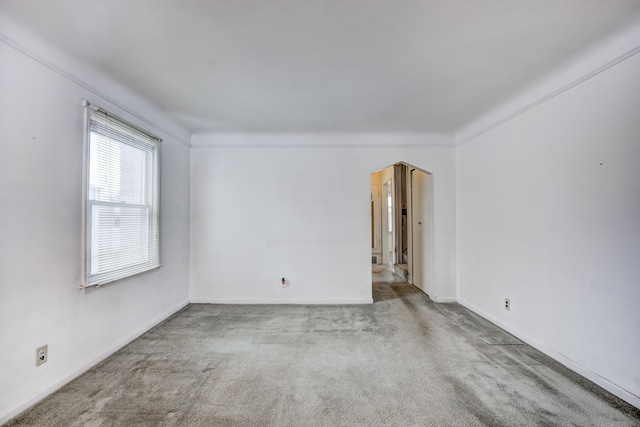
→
(0, 17, 189, 424)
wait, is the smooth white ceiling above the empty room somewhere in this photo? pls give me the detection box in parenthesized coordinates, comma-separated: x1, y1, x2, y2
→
(0, 0, 640, 132)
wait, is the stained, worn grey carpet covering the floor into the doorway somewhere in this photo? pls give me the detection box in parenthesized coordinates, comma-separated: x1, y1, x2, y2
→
(8, 268, 640, 426)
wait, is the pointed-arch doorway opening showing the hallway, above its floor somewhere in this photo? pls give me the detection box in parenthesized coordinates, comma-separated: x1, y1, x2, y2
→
(371, 162, 435, 295)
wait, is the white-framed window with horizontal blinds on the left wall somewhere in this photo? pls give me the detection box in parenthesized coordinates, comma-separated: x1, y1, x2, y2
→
(83, 102, 161, 287)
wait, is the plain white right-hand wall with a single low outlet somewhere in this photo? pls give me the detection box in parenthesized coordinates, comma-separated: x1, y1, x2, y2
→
(456, 23, 640, 407)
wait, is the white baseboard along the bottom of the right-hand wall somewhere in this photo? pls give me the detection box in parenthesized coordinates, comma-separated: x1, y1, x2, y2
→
(458, 299, 640, 408)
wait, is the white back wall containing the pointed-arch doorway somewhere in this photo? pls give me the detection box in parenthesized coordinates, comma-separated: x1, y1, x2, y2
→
(190, 135, 456, 303)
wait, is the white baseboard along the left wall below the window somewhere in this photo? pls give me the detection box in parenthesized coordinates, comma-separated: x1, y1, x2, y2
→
(0, 300, 189, 425)
